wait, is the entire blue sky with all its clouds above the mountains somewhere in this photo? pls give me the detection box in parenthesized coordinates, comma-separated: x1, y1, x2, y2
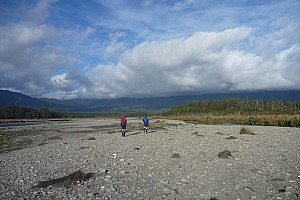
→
(0, 0, 300, 99)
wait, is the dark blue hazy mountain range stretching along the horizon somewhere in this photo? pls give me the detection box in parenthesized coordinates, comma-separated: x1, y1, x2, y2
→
(0, 90, 300, 112)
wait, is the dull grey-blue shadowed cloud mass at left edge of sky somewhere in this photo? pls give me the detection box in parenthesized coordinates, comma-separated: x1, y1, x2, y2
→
(0, 1, 76, 96)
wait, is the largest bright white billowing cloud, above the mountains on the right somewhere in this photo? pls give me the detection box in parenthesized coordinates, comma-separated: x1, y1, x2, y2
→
(83, 27, 300, 97)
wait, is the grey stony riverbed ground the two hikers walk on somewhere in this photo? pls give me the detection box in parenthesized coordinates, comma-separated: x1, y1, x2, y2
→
(0, 118, 300, 200)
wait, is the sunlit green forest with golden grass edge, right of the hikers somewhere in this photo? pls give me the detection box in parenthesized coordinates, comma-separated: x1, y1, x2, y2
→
(162, 98, 300, 127)
